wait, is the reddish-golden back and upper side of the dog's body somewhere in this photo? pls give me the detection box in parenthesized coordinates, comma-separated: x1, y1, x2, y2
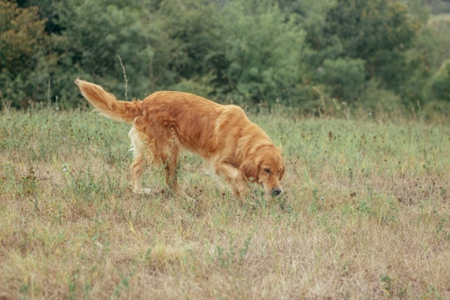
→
(133, 91, 255, 158)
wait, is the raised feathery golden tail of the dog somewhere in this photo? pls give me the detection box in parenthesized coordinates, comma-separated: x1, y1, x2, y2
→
(75, 79, 142, 123)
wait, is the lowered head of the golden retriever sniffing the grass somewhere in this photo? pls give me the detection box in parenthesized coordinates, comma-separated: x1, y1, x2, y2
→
(239, 145, 285, 197)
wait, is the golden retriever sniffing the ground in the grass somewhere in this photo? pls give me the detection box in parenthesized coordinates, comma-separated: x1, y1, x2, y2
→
(75, 79, 285, 200)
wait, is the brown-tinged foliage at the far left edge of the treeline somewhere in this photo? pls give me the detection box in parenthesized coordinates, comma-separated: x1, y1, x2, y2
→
(0, 0, 58, 108)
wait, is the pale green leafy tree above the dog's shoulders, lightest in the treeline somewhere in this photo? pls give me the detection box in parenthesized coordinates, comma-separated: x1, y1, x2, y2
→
(216, 1, 303, 103)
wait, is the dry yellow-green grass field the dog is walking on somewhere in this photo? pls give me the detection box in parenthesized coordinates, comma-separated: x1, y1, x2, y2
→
(0, 104, 450, 299)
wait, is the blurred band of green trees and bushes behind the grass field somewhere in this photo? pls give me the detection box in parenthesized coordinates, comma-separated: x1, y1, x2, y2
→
(0, 0, 450, 115)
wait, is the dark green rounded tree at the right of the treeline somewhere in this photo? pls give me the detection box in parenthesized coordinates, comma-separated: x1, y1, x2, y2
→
(306, 0, 421, 101)
